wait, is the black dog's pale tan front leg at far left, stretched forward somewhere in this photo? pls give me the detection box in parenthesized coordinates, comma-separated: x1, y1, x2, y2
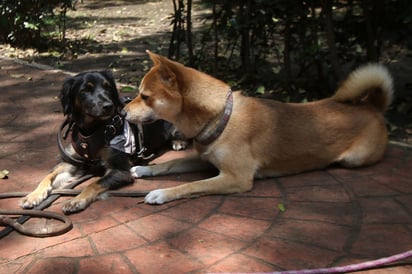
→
(19, 163, 74, 208)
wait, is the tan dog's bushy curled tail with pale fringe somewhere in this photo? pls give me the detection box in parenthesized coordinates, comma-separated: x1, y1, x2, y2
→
(332, 64, 393, 112)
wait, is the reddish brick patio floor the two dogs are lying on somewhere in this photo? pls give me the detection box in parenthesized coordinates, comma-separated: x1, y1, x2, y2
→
(0, 59, 412, 274)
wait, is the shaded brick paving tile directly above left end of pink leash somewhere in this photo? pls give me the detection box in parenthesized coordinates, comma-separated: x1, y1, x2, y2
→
(242, 237, 339, 270)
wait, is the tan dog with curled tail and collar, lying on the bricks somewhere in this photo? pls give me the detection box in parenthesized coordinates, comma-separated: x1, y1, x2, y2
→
(125, 51, 393, 204)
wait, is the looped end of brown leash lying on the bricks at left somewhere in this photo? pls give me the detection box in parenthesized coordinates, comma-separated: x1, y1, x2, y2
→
(0, 209, 73, 238)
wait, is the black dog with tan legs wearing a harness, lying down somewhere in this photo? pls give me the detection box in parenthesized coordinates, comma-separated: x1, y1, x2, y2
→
(19, 71, 185, 213)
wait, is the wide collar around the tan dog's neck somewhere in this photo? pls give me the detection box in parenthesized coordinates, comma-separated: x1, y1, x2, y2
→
(194, 89, 233, 146)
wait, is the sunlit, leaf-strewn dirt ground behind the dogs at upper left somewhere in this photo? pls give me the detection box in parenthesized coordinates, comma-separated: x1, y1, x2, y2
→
(0, 0, 182, 85)
